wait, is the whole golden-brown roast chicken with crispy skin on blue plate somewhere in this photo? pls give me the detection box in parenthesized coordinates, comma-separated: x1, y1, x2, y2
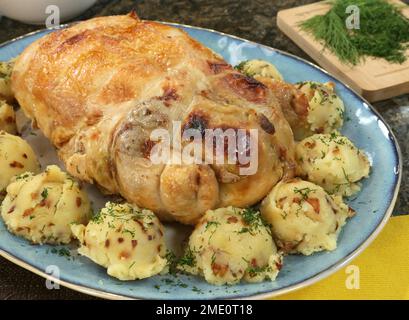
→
(12, 14, 295, 224)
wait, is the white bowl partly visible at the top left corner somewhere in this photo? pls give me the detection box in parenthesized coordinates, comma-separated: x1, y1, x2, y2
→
(0, 0, 96, 24)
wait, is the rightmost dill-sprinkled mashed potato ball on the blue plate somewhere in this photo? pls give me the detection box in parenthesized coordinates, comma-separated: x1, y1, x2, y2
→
(296, 132, 370, 196)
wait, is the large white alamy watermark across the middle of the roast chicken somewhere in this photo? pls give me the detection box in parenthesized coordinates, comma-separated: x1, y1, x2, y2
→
(149, 121, 258, 176)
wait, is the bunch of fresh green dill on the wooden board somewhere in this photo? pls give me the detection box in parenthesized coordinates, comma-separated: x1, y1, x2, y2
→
(300, 0, 409, 65)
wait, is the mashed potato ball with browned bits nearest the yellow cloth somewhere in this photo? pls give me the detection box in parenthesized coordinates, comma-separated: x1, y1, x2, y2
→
(261, 179, 354, 255)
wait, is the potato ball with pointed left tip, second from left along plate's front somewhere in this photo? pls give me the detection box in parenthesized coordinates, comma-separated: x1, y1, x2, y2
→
(72, 202, 167, 280)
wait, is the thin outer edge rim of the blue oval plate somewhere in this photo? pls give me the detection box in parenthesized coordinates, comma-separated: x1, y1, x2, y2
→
(0, 20, 403, 300)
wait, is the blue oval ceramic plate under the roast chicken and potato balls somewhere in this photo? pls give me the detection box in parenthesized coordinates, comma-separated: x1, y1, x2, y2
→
(0, 25, 402, 299)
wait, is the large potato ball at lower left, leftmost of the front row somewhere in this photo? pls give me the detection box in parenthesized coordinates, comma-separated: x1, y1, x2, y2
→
(1, 166, 91, 244)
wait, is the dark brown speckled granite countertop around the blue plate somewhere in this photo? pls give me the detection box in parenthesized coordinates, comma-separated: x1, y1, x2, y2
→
(0, 0, 409, 299)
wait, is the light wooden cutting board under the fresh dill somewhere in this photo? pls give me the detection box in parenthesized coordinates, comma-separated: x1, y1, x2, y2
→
(277, 1, 409, 102)
